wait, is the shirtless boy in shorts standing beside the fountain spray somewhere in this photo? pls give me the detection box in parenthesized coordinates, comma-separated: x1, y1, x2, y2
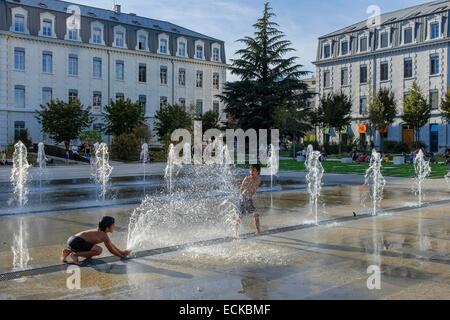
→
(241, 164, 261, 235)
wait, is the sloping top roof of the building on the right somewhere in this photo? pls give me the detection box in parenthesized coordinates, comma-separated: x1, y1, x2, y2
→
(320, 0, 450, 38)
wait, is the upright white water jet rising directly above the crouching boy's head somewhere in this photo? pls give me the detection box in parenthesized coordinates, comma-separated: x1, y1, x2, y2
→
(92, 143, 114, 201)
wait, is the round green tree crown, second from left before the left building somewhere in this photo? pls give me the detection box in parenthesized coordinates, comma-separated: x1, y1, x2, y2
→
(104, 99, 145, 136)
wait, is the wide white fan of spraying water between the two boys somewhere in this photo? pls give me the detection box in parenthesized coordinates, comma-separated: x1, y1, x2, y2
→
(127, 143, 240, 251)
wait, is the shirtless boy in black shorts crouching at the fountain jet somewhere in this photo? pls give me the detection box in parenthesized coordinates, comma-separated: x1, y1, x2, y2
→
(61, 217, 131, 265)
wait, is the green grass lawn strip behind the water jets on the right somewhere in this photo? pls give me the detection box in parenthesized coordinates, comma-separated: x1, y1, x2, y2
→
(280, 160, 450, 178)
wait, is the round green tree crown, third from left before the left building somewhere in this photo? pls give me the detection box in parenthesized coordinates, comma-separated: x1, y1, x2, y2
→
(155, 104, 193, 141)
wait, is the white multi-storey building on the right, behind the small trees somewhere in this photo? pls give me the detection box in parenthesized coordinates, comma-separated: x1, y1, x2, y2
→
(315, 1, 450, 152)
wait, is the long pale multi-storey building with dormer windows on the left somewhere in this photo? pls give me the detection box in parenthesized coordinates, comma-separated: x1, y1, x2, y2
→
(0, 0, 227, 148)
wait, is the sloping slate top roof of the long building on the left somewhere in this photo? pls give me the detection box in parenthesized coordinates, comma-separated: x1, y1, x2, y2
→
(6, 0, 223, 42)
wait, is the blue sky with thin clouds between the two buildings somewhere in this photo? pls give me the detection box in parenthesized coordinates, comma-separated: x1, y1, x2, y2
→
(73, 0, 429, 81)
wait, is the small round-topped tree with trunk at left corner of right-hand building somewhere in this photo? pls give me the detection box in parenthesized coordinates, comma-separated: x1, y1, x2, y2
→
(314, 92, 352, 153)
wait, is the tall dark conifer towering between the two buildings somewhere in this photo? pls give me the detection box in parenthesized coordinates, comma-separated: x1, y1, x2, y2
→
(219, 3, 309, 130)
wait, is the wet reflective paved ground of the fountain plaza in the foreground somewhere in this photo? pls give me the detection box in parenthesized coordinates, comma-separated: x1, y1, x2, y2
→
(0, 179, 450, 299)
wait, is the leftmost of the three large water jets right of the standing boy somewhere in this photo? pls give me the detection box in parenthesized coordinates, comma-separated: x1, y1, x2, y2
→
(305, 145, 324, 225)
